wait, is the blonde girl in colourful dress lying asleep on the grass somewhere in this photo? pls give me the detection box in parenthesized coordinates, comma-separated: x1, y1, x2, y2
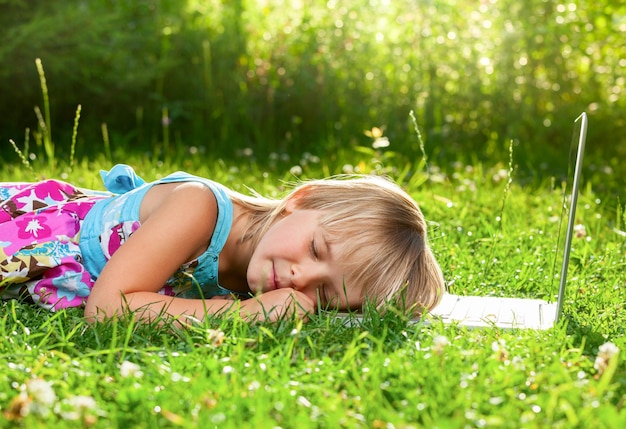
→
(0, 165, 444, 323)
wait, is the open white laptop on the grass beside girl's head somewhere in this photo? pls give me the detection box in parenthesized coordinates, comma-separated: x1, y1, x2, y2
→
(427, 112, 587, 329)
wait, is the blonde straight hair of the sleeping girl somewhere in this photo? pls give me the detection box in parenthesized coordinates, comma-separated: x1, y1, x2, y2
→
(231, 176, 445, 316)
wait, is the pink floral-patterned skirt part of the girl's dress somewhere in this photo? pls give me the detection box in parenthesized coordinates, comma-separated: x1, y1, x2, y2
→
(0, 180, 106, 310)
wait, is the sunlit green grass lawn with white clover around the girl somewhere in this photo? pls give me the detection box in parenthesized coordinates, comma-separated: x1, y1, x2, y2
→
(0, 151, 626, 428)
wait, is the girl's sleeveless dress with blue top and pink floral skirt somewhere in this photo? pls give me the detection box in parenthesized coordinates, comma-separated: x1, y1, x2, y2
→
(0, 164, 232, 311)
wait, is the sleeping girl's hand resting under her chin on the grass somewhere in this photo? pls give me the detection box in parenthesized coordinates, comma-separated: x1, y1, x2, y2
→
(241, 288, 315, 322)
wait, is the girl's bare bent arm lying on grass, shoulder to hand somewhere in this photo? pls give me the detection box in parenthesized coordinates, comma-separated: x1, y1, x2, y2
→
(85, 182, 313, 321)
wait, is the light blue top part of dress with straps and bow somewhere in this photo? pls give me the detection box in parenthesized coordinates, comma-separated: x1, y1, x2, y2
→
(79, 164, 233, 298)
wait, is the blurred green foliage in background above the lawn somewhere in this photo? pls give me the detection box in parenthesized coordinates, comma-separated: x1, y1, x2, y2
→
(0, 0, 626, 171)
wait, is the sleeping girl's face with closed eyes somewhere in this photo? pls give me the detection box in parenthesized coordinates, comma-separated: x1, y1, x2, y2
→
(247, 201, 362, 309)
